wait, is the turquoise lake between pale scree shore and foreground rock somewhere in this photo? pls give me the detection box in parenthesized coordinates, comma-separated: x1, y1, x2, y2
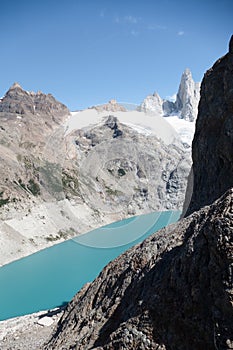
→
(0, 211, 180, 320)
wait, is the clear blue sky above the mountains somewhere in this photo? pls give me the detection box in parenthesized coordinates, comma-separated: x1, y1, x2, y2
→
(0, 0, 233, 110)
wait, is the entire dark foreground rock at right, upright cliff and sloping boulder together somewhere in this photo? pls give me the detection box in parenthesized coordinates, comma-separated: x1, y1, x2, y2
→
(44, 39, 233, 350)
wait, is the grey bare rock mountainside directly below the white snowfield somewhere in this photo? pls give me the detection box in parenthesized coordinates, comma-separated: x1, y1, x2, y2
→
(64, 115, 190, 217)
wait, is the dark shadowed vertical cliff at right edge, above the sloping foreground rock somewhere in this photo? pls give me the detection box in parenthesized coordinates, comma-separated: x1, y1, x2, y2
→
(186, 37, 233, 216)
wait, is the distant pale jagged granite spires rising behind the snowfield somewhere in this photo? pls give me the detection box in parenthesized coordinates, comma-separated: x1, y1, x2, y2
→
(140, 69, 200, 122)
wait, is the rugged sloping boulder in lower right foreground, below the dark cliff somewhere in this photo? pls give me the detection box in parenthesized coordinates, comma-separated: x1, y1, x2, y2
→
(45, 190, 233, 350)
